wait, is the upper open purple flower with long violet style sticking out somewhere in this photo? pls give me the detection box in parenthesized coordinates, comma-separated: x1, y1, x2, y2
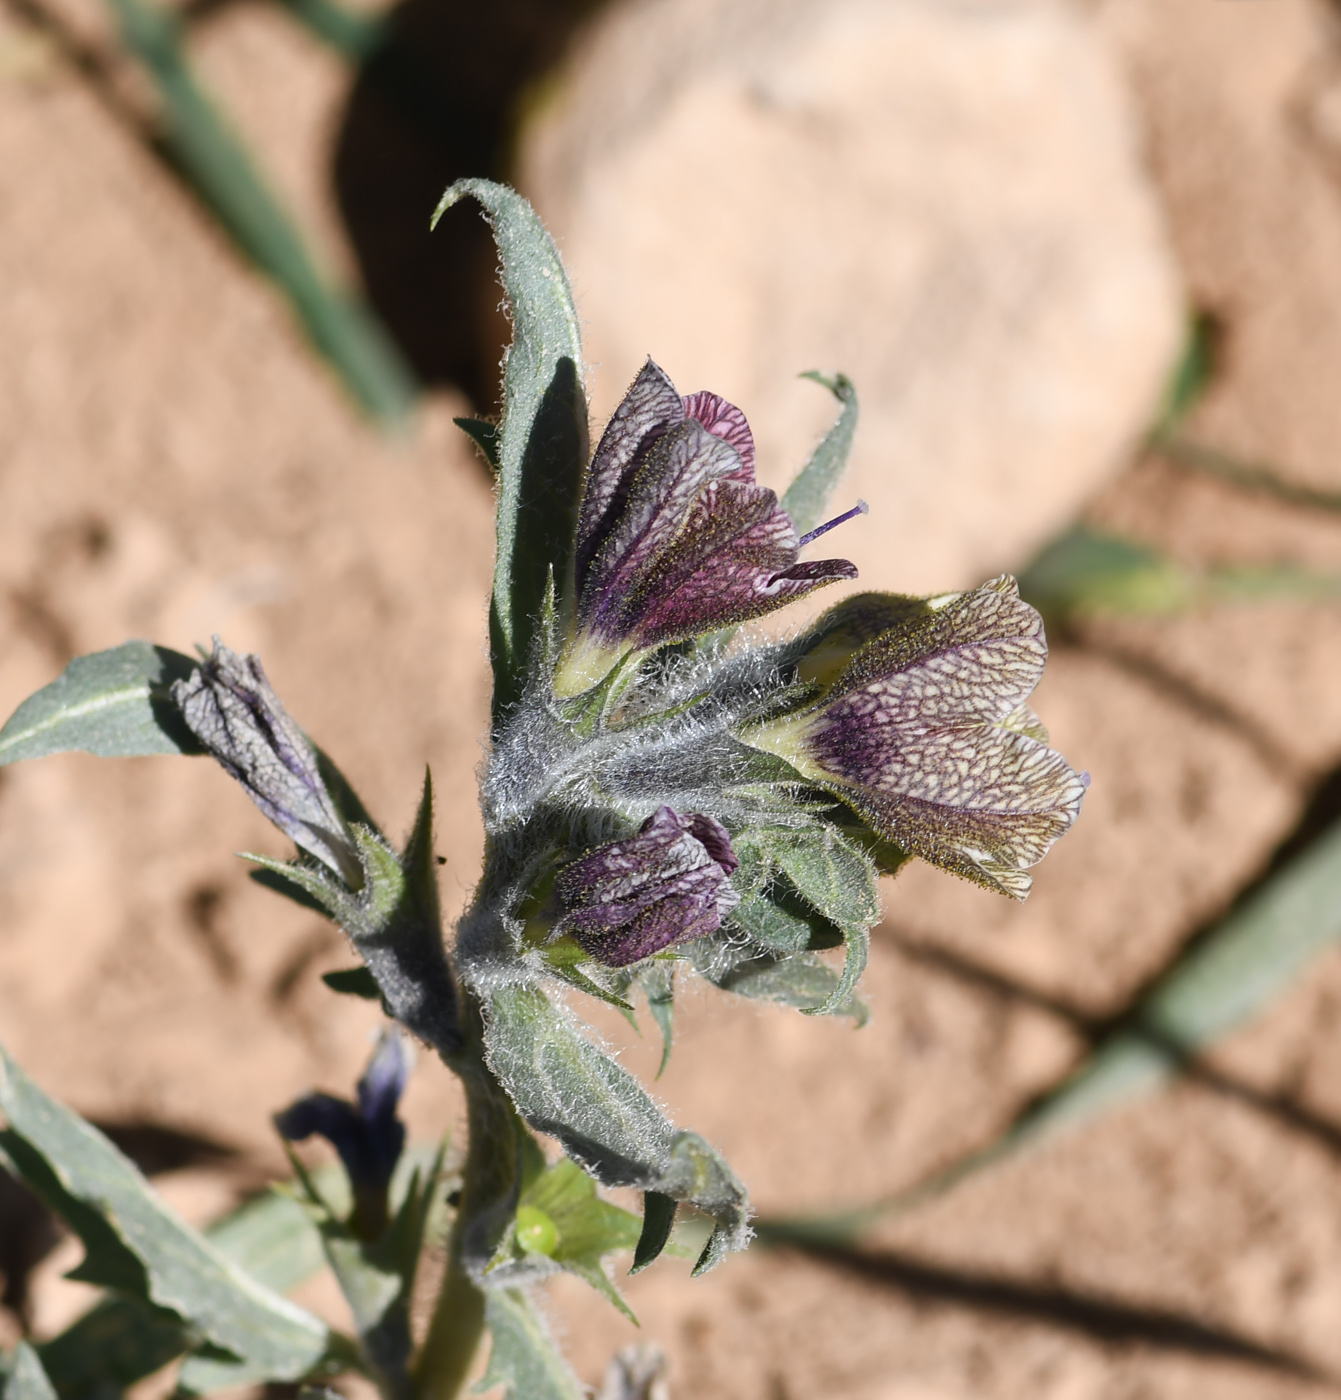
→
(556, 360, 857, 696)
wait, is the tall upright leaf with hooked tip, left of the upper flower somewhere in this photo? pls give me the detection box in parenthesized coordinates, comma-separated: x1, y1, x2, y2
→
(433, 179, 587, 728)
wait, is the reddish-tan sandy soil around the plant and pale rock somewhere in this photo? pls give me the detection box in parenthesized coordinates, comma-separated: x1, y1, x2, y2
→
(0, 0, 1341, 1400)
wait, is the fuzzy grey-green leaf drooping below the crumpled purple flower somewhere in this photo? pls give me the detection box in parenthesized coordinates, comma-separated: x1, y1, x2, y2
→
(484, 984, 750, 1273)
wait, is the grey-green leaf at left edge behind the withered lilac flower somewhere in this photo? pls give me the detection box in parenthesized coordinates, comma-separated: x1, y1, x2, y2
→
(0, 641, 203, 766)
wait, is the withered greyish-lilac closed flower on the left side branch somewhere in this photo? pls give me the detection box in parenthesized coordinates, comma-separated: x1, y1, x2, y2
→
(172, 637, 363, 889)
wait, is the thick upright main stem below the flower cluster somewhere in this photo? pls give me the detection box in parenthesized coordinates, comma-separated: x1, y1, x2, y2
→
(413, 988, 526, 1400)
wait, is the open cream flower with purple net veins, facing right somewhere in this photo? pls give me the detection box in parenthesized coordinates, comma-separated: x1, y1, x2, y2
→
(742, 577, 1089, 899)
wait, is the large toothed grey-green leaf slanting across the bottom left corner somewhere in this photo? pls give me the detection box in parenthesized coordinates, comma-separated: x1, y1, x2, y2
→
(0, 1049, 332, 1380)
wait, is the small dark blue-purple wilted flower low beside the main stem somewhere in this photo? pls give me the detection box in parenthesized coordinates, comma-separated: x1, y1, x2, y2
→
(274, 1030, 410, 1239)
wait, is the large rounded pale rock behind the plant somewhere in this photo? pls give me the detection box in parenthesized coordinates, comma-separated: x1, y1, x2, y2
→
(521, 0, 1181, 602)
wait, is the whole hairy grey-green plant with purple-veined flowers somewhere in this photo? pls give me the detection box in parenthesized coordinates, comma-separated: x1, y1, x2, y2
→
(0, 181, 1088, 1400)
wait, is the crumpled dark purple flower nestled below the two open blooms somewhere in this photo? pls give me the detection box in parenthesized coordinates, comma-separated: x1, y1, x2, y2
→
(554, 806, 739, 967)
